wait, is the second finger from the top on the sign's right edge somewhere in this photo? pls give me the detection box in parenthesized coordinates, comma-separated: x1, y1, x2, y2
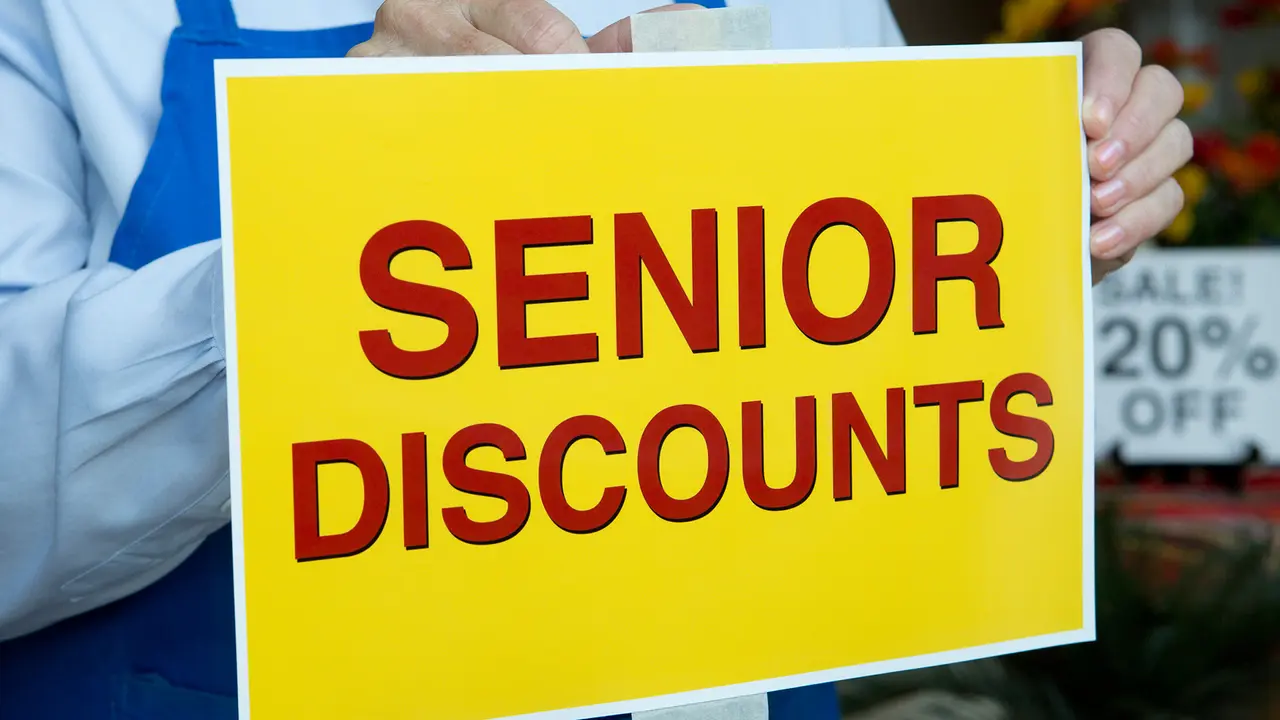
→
(1089, 65, 1183, 179)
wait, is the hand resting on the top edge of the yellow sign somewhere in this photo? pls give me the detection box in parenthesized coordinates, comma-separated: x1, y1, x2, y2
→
(347, 0, 699, 58)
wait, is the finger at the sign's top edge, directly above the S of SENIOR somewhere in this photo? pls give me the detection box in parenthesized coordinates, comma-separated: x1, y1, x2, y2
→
(368, 1, 520, 56)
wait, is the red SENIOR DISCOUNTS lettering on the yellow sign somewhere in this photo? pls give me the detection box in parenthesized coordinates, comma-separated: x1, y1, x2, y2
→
(293, 195, 1053, 561)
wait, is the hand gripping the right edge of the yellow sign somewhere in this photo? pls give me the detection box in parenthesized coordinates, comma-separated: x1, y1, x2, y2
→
(1083, 29, 1192, 283)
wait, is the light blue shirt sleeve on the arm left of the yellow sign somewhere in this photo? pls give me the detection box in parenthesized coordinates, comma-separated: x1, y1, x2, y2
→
(0, 0, 229, 641)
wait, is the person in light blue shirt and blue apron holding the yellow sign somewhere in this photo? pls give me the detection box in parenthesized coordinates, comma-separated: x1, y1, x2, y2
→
(0, 0, 1190, 720)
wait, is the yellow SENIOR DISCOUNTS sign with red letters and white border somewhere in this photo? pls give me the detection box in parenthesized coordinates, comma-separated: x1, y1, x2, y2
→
(219, 45, 1093, 720)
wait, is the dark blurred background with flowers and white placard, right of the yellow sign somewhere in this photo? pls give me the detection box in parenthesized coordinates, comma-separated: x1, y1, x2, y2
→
(842, 0, 1280, 720)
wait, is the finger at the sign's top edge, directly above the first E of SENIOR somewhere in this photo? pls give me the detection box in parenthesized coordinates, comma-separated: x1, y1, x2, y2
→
(465, 0, 590, 55)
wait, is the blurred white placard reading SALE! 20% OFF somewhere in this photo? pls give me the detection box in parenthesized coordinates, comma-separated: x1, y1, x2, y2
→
(1094, 249, 1280, 464)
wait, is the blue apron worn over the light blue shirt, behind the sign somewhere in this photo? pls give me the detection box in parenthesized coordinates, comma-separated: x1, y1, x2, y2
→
(0, 0, 838, 720)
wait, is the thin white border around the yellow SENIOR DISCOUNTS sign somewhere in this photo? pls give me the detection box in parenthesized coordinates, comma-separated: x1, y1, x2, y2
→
(214, 42, 1097, 720)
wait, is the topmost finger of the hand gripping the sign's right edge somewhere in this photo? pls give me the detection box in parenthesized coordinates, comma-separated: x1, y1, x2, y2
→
(1083, 28, 1142, 140)
